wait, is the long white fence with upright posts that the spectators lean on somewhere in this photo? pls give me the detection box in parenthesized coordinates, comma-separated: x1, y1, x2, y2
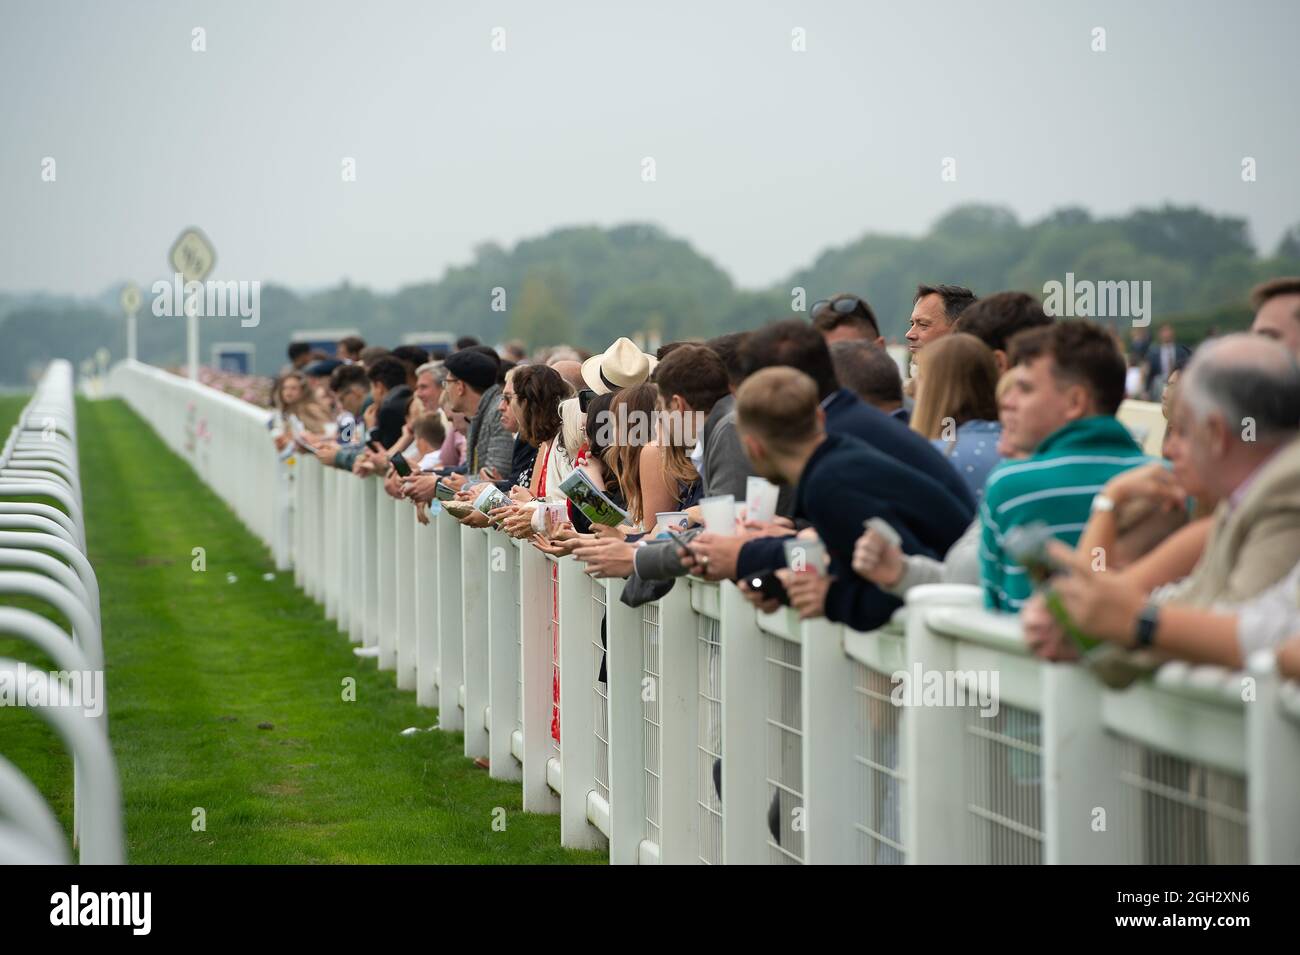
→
(113, 365, 1300, 864)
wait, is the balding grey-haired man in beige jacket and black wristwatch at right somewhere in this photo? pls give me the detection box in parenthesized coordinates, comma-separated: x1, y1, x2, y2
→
(1035, 334, 1300, 667)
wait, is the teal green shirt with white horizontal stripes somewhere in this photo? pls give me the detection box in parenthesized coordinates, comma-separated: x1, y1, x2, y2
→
(979, 414, 1152, 612)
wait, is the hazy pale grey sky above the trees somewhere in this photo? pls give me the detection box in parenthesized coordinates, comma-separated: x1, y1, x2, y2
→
(0, 0, 1300, 294)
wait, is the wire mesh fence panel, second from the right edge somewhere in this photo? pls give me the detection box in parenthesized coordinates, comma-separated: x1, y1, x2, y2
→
(963, 703, 1043, 865)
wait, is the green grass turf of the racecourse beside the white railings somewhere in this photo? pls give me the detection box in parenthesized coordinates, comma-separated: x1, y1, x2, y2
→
(0, 400, 606, 863)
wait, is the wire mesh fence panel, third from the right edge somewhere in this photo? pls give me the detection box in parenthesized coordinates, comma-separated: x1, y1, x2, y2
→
(853, 663, 906, 865)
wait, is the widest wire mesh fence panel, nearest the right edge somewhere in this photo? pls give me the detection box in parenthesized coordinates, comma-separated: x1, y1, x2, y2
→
(1109, 735, 1249, 865)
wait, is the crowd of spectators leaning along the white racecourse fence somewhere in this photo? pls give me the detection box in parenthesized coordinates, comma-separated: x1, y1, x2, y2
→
(272, 272, 1300, 696)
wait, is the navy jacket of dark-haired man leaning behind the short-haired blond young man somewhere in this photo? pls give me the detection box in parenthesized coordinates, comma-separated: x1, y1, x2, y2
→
(736, 388, 975, 579)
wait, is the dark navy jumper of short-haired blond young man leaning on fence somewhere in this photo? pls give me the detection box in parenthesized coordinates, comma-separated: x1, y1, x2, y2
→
(783, 434, 974, 630)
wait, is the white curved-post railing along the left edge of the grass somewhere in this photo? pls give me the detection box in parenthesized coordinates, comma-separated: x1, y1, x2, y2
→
(0, 361, 125, 864)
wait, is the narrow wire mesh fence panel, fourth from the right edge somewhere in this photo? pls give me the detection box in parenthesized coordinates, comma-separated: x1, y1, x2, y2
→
(763, 634, 803, 865)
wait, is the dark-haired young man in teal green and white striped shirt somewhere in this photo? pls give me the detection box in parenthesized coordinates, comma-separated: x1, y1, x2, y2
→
(979, 320, 1151, 612)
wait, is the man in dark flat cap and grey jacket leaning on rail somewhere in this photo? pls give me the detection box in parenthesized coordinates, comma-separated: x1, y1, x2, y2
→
(443, 348, 515, 490)
